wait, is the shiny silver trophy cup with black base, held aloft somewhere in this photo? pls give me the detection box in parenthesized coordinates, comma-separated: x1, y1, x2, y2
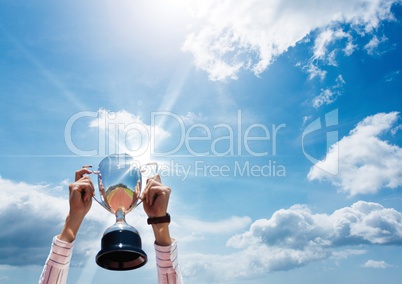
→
(84, 154, 158, 270)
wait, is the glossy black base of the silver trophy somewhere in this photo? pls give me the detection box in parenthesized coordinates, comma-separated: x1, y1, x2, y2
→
(96, 230, 148, 270)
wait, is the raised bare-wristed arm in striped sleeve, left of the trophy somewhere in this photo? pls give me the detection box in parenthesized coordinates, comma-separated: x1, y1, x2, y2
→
(39, 168, 94, 284)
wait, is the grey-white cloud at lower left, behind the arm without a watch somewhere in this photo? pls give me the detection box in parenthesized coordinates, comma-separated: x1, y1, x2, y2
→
(0, 177, 127, 266)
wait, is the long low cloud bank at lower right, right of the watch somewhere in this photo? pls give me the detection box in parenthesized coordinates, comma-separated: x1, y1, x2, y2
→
(181, 201, 402, 283)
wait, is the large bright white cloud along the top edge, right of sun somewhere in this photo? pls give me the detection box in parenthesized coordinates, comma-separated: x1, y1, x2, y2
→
(182, 0, 400, 80)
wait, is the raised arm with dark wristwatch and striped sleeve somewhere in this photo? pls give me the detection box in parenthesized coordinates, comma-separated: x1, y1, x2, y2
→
(141, 175, 183, 284)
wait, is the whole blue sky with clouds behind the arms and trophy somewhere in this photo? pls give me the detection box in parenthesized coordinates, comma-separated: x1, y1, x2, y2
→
(0, 0, 402, 283)
